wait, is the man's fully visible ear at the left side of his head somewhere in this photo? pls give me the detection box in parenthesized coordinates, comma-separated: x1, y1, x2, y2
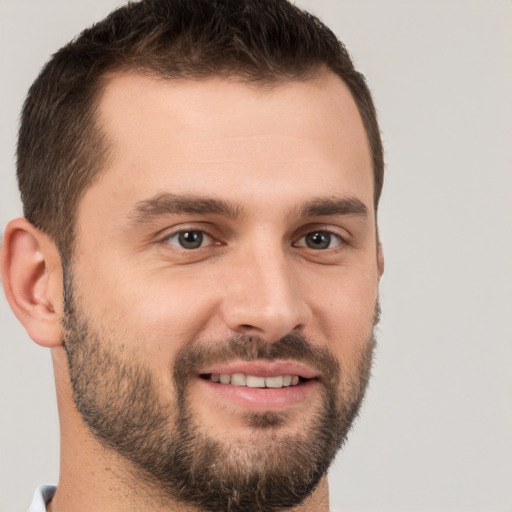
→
(0, 218, 63, 347)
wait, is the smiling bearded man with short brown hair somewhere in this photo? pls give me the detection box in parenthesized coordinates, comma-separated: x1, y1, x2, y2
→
(2, 0, 383, 512)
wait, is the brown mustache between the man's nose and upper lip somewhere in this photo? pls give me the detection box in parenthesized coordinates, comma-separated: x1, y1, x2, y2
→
(174, 333, 340, 387)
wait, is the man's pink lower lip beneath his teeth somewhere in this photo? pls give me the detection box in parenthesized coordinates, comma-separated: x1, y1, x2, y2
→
(199, 379, 319, 412)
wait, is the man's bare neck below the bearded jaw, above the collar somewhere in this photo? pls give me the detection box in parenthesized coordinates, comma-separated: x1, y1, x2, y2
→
(47, 349, 329, 512)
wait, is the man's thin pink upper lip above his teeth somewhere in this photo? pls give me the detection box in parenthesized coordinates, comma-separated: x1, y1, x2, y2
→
(200, 360, 319, 379)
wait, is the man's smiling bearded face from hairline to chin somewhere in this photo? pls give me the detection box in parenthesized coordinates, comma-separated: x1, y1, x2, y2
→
(64, 74, 380, 511)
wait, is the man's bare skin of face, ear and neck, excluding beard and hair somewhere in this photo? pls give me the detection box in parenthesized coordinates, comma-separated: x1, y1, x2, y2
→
(2, 72, 383, 512)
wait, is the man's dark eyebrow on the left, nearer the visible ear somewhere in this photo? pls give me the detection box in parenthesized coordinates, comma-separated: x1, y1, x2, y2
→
(128, 193, 240, 224)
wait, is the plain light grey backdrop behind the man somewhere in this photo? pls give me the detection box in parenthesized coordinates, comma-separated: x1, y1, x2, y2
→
(0, 0, 512, 512)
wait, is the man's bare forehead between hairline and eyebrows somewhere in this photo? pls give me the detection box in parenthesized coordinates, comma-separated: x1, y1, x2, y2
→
(81, 72, 373, 222)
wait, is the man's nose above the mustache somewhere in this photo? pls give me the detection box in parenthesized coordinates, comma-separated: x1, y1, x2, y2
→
(221, 242, 311, 341)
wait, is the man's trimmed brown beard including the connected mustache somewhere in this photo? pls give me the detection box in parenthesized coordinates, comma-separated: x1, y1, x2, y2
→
(63, 270, 378, 512)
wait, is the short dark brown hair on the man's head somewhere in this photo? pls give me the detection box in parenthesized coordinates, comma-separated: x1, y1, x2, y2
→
(17, 0, 384, 258)
